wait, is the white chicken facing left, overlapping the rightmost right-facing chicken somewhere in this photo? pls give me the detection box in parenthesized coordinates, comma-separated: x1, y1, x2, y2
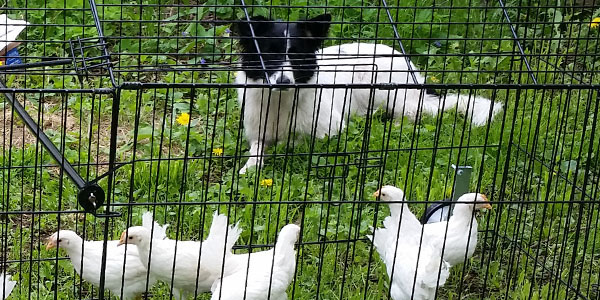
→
(367, 186, 450, 300)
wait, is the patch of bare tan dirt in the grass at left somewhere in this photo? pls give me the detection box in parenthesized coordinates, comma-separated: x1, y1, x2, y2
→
(0, 96, 188, 178)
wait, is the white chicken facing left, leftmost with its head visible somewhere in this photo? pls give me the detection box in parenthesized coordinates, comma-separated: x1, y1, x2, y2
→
(46, 212, 166, 299)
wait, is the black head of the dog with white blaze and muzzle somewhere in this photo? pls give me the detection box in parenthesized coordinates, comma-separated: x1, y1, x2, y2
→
(238, 14, 331, 90)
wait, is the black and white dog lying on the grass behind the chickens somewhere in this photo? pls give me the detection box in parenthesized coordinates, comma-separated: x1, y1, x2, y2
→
(236, 14, 502, 174)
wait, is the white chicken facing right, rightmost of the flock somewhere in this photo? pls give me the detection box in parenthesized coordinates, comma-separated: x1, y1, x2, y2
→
(424, 193, 492, 266)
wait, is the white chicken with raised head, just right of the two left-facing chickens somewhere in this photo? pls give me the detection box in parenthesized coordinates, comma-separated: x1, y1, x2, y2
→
(211, 224, 300, 300)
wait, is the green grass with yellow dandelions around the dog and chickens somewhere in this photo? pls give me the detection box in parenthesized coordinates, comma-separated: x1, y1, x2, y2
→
(0, 0, 600, 299)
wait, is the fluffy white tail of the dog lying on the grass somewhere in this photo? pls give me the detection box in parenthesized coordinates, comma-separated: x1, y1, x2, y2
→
(422, 93, 502, 126)
